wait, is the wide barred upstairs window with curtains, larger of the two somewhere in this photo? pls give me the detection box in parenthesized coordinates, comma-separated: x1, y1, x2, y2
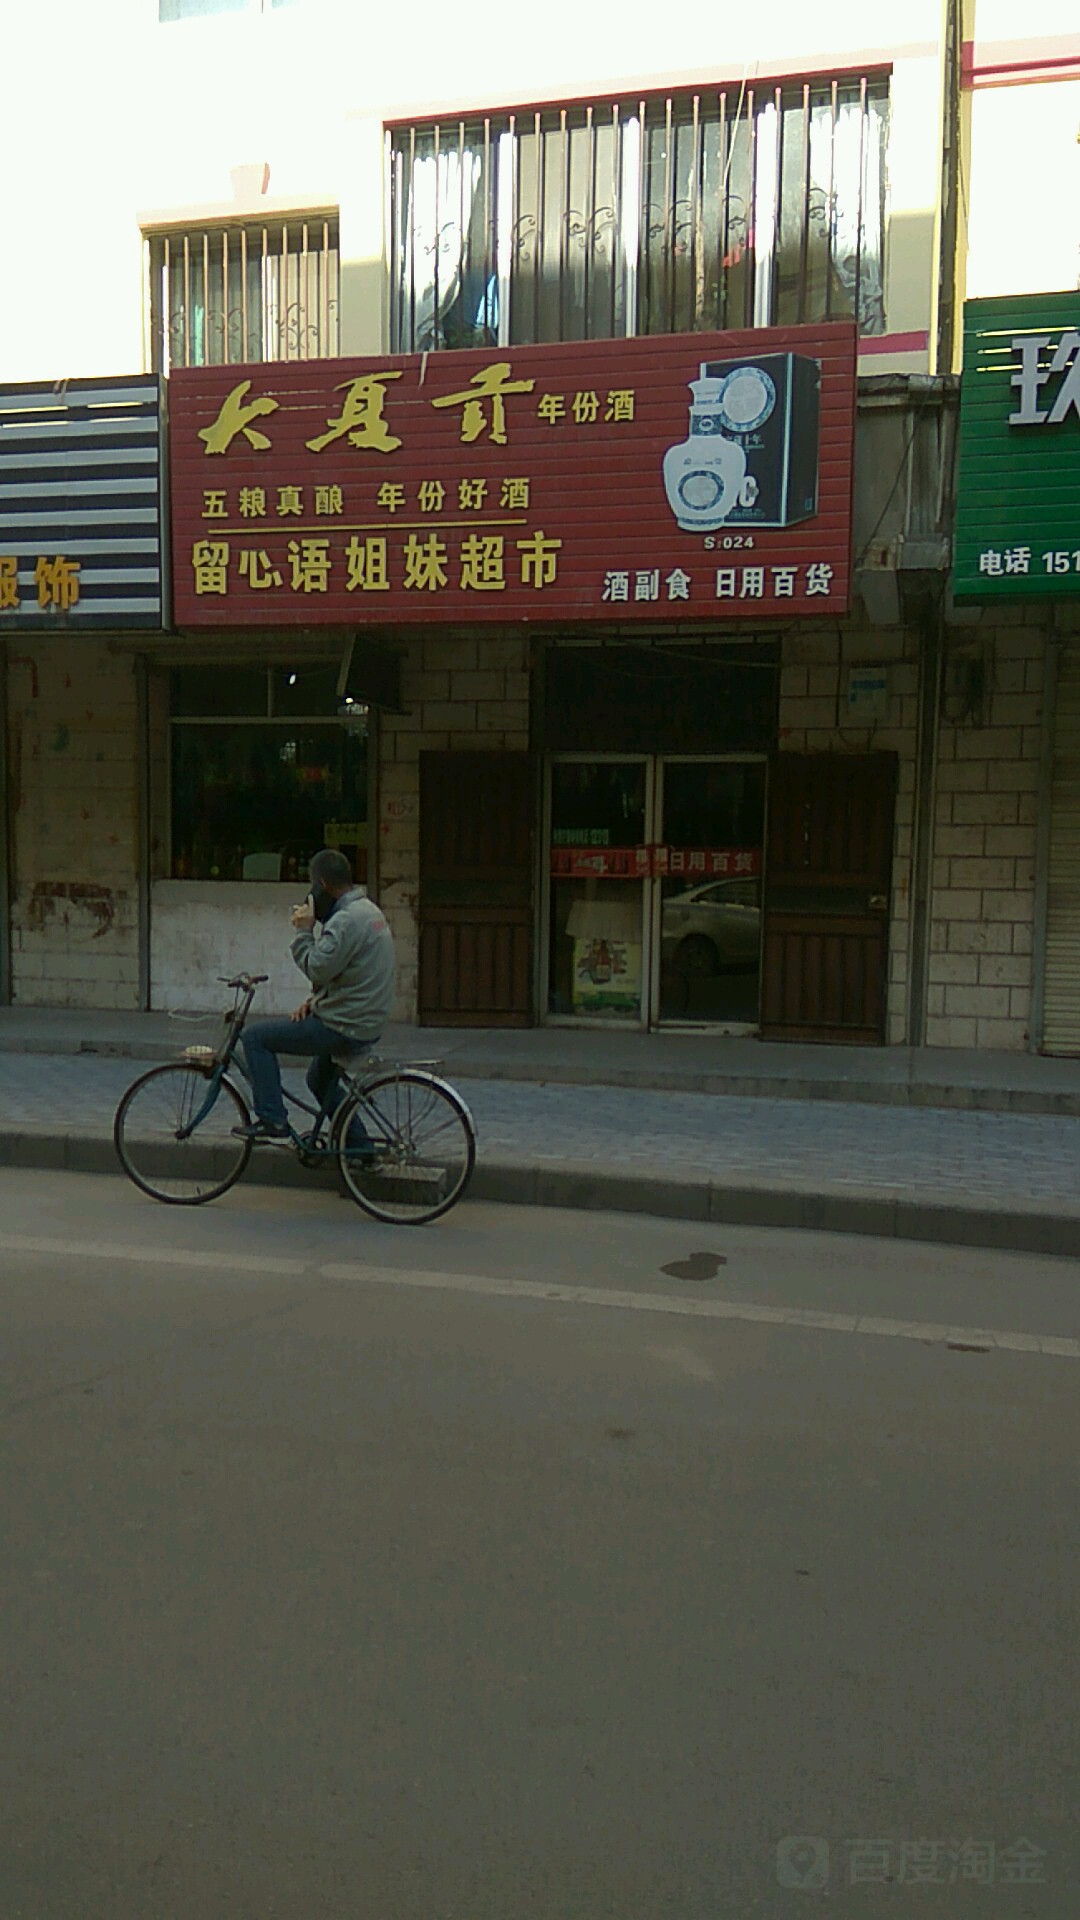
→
(388, 77, 888, 351)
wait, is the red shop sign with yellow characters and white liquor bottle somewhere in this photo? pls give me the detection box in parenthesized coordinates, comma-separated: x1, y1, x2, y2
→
(169, 323, 855, 628)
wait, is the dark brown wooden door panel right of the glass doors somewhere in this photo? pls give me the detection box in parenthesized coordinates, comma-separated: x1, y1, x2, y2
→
(761, 753, 896, 1044)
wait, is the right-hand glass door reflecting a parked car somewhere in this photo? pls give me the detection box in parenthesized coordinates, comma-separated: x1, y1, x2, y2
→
(653, 758, 765, 1027)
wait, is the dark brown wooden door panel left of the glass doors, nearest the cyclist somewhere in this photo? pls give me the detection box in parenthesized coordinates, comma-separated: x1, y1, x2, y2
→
(419, 753, 536, 1027)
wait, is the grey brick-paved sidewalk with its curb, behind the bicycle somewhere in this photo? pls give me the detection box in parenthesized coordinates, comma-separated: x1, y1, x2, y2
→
(0, 1052, 1080, 1254)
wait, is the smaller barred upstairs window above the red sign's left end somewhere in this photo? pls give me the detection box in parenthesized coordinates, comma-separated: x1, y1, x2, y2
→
(146, 213, 338, 372)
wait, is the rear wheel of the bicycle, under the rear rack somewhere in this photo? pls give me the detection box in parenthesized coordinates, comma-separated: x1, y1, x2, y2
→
(334, 1069, 477, 1227)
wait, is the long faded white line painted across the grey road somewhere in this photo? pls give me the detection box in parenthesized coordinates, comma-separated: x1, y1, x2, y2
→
(0, 1233, 1080, 1359)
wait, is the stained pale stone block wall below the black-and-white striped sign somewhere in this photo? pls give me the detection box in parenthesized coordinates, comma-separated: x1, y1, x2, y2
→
(8, 636, 138, 1008)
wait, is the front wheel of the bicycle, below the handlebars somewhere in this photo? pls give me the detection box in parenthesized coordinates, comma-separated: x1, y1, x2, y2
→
(113, 1060, 252, 1206)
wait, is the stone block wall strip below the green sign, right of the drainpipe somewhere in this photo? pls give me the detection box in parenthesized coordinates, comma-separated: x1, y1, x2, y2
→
(926, 626, 1045, 1050)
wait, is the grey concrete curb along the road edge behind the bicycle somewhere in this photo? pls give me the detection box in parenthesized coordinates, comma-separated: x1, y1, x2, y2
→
(8, 1129, 1080, 1260)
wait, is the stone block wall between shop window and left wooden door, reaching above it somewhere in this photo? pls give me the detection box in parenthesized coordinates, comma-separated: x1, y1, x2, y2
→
(375, 628, 528, 1020)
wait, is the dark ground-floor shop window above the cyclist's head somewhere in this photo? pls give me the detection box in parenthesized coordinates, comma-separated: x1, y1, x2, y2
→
(169, 662, 367, 881)
